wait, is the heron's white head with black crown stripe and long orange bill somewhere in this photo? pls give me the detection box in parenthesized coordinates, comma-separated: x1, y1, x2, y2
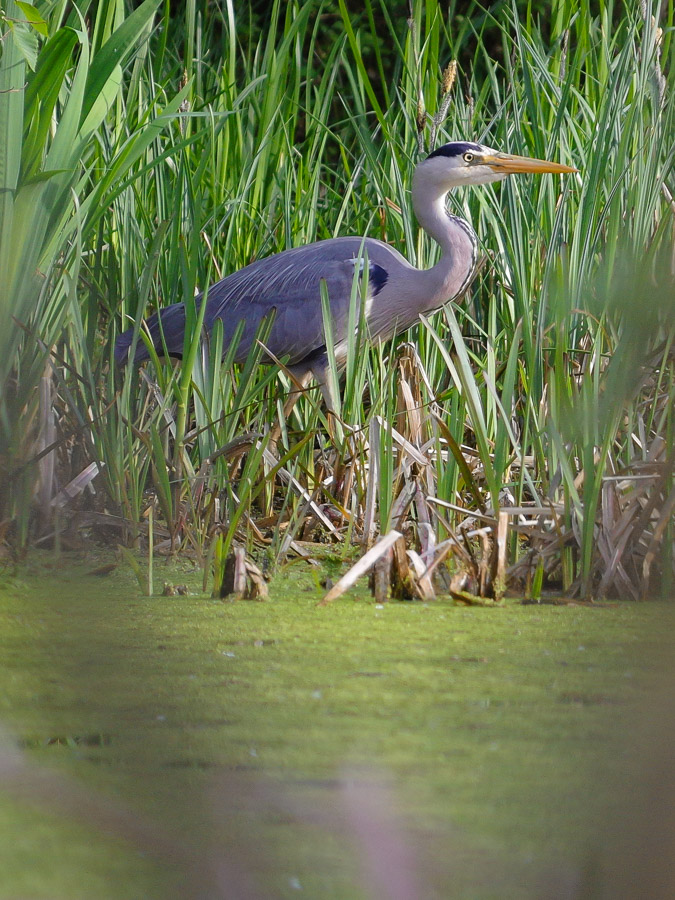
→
(418, 141, 578, 190)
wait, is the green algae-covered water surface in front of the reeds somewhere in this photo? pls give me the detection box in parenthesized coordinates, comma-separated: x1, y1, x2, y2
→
(0, 557, 673, 900)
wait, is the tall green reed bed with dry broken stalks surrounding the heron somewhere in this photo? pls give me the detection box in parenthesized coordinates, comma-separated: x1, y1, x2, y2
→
(0, 0, 675, 603)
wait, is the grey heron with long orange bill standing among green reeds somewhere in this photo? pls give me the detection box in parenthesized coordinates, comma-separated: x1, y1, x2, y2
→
(115, 141, 577, 410)
